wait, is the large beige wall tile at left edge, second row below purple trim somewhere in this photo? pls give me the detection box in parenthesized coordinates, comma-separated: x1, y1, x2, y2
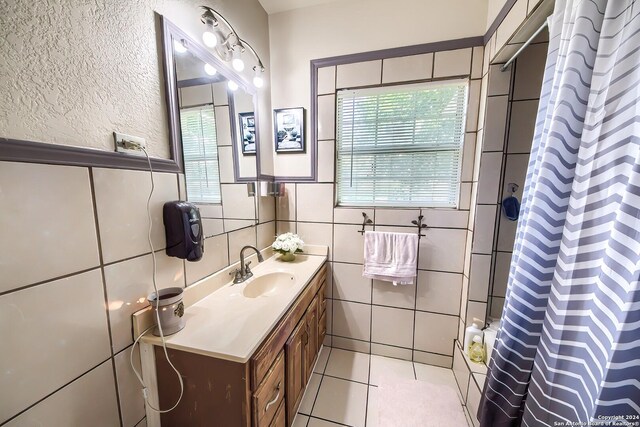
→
(0, 269, 111, 422)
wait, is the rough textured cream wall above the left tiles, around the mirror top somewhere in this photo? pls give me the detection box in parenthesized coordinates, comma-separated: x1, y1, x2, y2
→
(0, 0, 269, 158)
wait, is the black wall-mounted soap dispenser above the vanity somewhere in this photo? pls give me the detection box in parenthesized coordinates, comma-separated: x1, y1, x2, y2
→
(162, 200, 204, 261)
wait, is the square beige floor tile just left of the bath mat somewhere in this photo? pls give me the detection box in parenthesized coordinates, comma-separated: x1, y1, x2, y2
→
(310, 377, 367, 427)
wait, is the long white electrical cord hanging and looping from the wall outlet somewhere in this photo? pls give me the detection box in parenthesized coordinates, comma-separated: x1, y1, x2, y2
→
(129, 146, 184, 414)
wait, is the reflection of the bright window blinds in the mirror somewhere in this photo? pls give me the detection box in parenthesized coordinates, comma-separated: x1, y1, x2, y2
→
(180, 105, 222, 203)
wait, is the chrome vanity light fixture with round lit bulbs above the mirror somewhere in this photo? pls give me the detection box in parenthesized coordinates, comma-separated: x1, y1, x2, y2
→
(200, 6, 265, 87)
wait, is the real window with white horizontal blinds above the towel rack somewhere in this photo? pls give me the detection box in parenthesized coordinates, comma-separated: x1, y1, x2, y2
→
(336, 80, 467, 207)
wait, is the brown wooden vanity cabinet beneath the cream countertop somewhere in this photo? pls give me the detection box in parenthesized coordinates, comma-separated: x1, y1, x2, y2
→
(154, 265, 327, 427)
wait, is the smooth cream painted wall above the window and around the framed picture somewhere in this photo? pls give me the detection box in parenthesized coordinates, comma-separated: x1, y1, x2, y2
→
(269, 0, 487, 176)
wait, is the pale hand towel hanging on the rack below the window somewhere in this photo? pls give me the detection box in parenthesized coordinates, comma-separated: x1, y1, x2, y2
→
(362, 231, 418, 285)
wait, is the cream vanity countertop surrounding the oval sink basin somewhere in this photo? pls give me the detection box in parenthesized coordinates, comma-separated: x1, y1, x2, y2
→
(142, 251, 327, 363)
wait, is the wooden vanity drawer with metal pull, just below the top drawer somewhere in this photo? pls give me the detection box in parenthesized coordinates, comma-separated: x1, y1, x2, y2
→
(253, 352, 285, 427)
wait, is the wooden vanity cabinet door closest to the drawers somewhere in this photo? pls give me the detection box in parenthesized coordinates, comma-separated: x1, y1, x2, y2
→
(284, 317, 308, 425)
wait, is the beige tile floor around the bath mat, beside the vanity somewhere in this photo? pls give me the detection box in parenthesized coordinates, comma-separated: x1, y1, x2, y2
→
(293, 346, 471, 427)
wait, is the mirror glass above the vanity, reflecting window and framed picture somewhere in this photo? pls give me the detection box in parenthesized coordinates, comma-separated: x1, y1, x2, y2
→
(162, 18, 259, 232)
